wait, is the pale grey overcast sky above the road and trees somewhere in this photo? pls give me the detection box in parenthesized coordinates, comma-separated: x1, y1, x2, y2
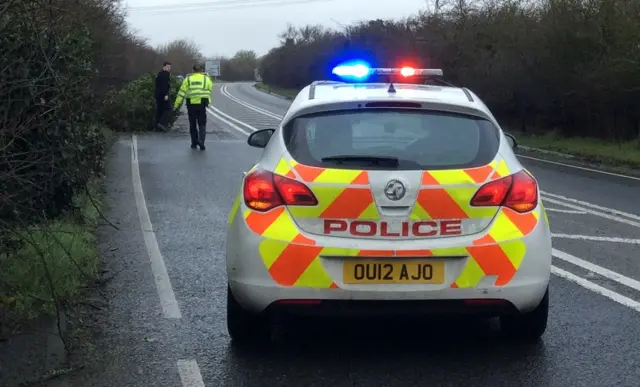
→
(124, 0, 427, 56)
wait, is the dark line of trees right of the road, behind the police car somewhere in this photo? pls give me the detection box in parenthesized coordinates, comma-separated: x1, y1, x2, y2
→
(259, 0, 640, 142)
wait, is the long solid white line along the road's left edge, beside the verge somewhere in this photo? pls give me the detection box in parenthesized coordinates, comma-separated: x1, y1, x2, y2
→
(131, 135, 182, 318)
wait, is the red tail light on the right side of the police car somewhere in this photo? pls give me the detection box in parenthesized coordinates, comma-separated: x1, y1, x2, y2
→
(471, 170, 538, 213)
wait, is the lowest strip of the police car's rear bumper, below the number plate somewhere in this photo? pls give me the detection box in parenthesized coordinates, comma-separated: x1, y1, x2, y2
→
(229, 278, 548, 316)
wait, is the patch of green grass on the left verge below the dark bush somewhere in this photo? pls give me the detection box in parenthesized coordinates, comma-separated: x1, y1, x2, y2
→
(0, 172, 102, 336)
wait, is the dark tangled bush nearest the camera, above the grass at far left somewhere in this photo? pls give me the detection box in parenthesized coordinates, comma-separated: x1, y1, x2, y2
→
(0, 0, 105, 224)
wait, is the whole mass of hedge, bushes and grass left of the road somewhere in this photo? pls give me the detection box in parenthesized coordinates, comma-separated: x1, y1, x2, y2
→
(0, 0, 202, 330)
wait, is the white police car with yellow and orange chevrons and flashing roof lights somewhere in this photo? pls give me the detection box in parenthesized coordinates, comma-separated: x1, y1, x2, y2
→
(226, 59, 551, 342)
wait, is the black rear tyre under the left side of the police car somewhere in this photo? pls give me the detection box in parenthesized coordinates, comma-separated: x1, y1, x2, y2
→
(227, 286, 271, 345)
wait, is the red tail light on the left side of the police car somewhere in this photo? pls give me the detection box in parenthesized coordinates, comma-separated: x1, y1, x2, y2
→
(244, 170, 318, 212)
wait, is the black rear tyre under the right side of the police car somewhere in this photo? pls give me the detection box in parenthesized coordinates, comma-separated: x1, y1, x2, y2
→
(500, 287, 549, 341)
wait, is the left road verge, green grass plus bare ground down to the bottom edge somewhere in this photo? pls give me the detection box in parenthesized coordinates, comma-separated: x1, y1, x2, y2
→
(0, 174, 102, 385)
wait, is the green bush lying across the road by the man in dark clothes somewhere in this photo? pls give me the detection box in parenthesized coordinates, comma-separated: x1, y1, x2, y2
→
(102, 74, 180, 132)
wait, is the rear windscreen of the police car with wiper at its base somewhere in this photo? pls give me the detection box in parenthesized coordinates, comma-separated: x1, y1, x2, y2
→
(283, 109, 500, 170)
